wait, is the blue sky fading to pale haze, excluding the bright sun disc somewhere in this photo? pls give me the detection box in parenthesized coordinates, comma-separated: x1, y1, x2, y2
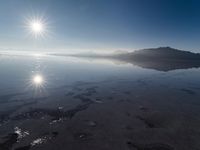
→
(0, 0, 200, 52)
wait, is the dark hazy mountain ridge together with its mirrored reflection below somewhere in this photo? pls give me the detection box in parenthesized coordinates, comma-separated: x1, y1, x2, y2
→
(53, 47, 200, 71)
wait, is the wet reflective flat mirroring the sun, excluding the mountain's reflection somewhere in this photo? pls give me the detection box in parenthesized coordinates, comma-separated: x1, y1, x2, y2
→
(0, 55, 200, 150)
